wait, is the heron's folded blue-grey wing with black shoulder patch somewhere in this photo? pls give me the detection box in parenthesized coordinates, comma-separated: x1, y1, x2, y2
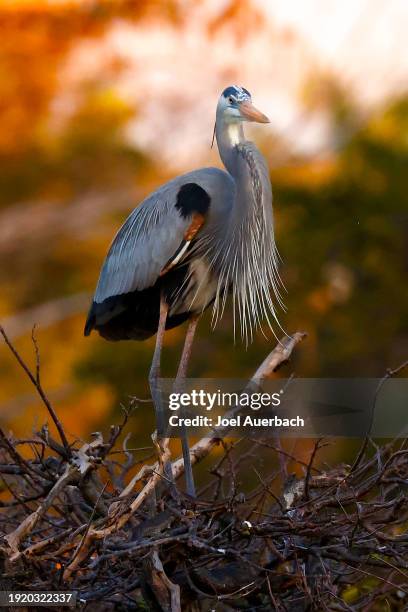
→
(94, 168, 231, 303)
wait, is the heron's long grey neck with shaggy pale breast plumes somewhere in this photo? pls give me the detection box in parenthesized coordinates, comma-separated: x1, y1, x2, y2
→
(212, 117, 280, 339)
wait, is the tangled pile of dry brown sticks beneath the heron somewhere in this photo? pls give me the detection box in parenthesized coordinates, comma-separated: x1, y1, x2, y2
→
(0, 333, 408, 612)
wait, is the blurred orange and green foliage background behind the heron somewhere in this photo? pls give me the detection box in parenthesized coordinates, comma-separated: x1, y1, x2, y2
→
(0, 0, 408, 460)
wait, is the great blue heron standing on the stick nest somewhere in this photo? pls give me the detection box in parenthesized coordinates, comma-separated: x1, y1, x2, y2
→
(85, 86, 280, 494)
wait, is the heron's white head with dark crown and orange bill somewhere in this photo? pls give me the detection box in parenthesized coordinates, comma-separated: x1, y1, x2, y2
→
(217, 85, 269, 123)
